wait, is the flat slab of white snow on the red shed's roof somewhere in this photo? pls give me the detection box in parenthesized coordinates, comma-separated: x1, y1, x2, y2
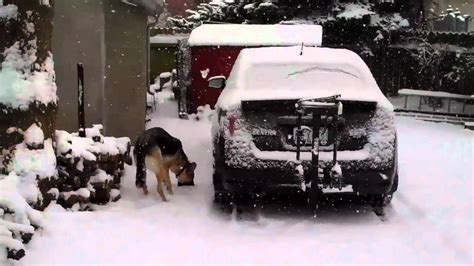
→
(189, 24, 323, 46)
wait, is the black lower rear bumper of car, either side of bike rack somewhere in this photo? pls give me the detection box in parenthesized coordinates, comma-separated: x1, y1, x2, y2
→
(221, 164, 396, 195)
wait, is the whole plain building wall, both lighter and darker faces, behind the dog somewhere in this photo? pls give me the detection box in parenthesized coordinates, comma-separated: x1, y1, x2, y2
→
(53, 0, 148, 140)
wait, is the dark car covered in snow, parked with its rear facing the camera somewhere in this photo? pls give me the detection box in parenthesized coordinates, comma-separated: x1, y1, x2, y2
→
(209, 47, 398, 212)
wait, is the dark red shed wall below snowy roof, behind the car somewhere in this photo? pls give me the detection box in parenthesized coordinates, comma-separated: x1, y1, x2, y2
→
(187, 46, 246, 113)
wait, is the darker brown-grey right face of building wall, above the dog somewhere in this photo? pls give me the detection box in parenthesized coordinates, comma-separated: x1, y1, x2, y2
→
(103, 0, 148, 141)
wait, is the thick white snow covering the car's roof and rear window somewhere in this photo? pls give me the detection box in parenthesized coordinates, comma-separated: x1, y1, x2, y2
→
(218, 46, 393, 109)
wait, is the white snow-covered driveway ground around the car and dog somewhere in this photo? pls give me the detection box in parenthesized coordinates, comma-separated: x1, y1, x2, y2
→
(18, 99, 474, 265)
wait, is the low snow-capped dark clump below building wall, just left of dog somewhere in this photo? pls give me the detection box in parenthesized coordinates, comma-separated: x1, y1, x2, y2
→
(56, 125, 130, 210)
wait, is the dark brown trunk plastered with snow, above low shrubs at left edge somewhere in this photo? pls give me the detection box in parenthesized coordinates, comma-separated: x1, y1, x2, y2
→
(0, 1, 58, 149)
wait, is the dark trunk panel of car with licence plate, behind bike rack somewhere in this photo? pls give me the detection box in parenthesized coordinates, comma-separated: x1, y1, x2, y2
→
(242, 100, 377, 154)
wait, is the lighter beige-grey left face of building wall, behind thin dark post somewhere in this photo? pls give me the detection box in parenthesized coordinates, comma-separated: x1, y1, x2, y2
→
(52, 0, 105, 132)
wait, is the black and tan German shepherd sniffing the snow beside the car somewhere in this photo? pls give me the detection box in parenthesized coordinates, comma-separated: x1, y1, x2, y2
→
(133, 127, 197, 201)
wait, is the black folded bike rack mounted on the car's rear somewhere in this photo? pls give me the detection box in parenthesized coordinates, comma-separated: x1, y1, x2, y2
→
(295, 95, 344, 208)
